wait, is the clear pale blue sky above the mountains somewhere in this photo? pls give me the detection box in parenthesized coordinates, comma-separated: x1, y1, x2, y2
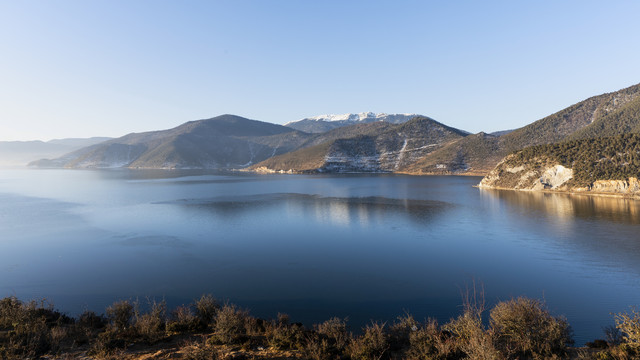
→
(0, 0, 640, 140)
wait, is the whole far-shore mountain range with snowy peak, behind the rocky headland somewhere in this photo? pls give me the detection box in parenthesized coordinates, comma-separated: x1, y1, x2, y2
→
(31, 84, 640, 175)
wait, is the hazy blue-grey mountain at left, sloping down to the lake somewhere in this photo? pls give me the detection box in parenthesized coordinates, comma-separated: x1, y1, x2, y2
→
(30, 115, 310, 169)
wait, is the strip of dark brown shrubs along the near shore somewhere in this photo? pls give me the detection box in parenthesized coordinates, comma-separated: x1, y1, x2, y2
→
(0, 295, 640, 360)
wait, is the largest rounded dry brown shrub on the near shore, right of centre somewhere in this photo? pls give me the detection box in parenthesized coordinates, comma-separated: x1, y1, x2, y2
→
(490, 297, 572, 358)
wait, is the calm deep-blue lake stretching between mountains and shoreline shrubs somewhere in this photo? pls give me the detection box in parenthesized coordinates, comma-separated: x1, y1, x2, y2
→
(0, 169, 640, 344)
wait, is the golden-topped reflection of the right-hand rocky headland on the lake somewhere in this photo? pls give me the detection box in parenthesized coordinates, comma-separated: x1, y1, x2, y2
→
(481, 190, 640, 276)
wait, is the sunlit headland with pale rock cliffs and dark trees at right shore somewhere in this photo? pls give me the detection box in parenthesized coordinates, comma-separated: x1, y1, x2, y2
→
(478, 134, 640, 197)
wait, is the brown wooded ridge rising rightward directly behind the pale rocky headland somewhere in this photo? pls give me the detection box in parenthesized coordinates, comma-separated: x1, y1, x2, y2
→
(407, 84, 640, 175)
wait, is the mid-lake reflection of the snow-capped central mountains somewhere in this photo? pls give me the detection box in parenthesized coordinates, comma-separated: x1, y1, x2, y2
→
(165, 193, 454, 227)
